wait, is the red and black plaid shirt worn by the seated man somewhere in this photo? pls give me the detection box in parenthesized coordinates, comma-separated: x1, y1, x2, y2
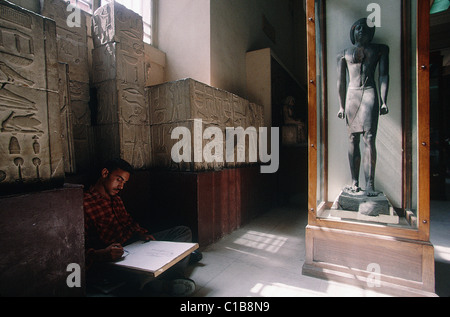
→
(83, 190, 148, 252)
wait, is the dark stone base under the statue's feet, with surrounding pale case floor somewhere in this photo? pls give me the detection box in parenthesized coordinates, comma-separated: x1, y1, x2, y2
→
(330, 187, 399, 224)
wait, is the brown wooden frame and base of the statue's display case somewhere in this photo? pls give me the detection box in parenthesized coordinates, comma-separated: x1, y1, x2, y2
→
(303, 0, 434, 296)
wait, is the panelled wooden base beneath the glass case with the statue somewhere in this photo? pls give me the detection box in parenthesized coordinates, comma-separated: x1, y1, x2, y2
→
(303, 225, 436, 296)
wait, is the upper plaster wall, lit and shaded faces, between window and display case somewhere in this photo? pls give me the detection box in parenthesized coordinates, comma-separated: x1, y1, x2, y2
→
(158, 0, 306, 98)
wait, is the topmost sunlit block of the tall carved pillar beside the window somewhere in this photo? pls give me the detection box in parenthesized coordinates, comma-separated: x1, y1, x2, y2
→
(92, 1, 144, 47)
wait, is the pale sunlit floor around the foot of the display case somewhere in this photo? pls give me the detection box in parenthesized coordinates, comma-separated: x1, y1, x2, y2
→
(184, 201, 450, 297)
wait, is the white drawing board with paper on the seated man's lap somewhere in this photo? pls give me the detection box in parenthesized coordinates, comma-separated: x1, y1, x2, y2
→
(113, 241, 199, 277)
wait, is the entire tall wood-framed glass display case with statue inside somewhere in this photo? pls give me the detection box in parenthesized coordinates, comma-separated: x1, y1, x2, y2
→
(303, 0, 434, 295)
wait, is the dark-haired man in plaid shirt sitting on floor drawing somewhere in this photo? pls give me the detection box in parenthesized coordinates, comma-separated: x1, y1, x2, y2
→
(83, 159, 201, 296)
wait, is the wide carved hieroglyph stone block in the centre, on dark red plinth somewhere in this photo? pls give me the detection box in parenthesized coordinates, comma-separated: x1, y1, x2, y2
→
(146, 79, 264, 171)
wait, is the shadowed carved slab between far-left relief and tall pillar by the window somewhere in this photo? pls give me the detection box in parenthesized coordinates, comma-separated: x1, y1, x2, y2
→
(41, 0, 94, 173)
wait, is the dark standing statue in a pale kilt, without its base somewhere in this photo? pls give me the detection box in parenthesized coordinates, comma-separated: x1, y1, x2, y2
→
(337, 18, 389, 196)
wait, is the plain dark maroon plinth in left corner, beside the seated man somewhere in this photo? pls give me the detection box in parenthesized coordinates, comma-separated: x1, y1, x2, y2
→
(0, 186, 85, 297)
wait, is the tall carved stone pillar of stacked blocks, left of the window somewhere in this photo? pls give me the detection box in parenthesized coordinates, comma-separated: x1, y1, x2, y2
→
(92, 2, 151, 169)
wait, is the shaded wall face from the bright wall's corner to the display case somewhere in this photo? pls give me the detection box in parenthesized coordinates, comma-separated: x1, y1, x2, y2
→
(211, 0, 306, 97)
